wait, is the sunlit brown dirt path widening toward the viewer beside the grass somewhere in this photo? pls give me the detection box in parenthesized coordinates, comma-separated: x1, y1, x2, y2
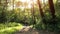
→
(15, 26, 38, 34)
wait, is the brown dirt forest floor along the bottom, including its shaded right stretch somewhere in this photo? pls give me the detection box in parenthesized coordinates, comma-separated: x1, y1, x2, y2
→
(15, 26, 59, 34)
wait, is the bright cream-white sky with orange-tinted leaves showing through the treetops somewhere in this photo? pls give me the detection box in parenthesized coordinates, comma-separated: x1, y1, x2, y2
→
(9, 0, 48, 9)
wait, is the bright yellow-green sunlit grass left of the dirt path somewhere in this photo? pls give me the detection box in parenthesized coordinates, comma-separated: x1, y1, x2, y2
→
(0, 22, 23, 34)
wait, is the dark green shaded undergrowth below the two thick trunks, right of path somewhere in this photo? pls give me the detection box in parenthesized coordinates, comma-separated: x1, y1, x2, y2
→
(35, 17, 60, 32)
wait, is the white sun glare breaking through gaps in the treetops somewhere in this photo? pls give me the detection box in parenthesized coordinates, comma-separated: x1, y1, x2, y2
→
(10, 0, 47, 9)
